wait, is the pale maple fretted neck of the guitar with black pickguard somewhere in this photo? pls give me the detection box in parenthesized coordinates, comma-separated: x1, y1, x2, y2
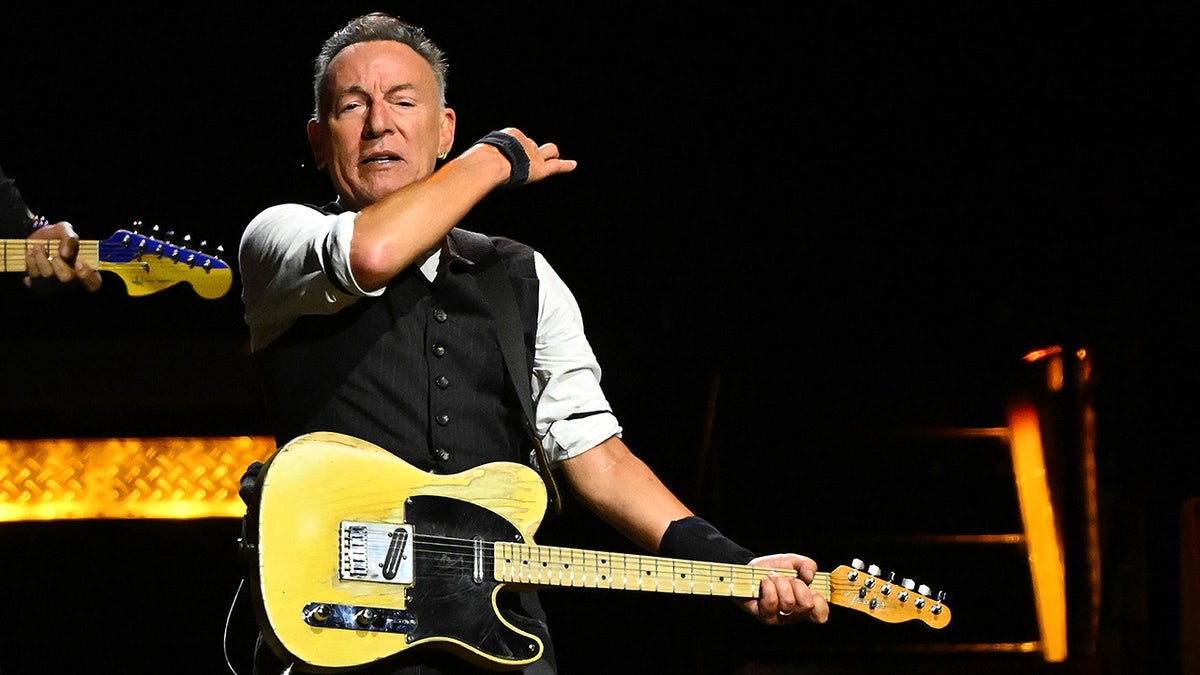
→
(493, 542, 832, 601)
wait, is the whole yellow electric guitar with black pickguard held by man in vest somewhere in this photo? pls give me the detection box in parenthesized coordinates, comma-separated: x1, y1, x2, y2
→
(248, 432, 950, 673)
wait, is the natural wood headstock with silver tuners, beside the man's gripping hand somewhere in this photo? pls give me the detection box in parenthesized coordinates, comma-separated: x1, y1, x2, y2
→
(829, 560, 950, 628)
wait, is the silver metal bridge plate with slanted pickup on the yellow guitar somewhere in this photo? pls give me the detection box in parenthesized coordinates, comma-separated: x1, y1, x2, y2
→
(338, 520, 413, 584)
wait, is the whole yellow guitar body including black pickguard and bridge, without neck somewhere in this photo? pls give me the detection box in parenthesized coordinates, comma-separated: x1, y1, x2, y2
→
(251, 432, 547, 671)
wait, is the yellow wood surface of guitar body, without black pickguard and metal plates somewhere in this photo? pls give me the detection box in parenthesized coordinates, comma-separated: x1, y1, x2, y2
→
(257, 432, 547, 670)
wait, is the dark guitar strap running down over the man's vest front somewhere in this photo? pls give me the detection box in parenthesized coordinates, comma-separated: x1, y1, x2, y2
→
(473, 253, 563, 513)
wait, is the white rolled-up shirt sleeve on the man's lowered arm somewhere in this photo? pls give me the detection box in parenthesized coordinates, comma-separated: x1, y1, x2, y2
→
(533, 253, 622, 464)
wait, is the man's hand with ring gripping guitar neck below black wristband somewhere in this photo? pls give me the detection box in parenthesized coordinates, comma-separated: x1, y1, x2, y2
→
(738, 554, 829, 626)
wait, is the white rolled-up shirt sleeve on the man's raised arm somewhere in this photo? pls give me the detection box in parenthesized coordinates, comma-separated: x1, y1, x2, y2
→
(238, 204, 383, 350)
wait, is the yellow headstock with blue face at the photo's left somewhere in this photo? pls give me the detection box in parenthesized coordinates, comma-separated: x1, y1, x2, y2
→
(100, 224, 233, 300)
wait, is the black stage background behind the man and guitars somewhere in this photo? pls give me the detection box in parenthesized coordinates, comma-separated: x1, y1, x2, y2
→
(0, 1, 1200, 674)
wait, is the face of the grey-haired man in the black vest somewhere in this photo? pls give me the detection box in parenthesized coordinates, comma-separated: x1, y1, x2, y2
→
(308, 41, 455, 209)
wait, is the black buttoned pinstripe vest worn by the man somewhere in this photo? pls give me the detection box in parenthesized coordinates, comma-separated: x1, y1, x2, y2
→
(254, 223, 538, 473)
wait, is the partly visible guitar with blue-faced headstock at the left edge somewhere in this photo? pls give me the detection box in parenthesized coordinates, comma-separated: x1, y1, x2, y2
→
(0, 229, 233, 300)
